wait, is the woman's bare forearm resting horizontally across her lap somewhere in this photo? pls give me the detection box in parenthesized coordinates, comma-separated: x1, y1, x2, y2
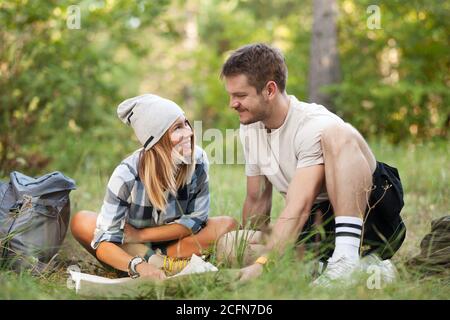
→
(139, 223, 192, 242)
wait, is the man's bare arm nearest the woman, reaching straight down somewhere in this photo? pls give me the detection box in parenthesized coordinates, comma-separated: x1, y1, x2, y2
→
(242, 176, 272, 229)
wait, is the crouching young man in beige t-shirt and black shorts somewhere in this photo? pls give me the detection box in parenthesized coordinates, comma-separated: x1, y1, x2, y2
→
(221, 44, 405, 285)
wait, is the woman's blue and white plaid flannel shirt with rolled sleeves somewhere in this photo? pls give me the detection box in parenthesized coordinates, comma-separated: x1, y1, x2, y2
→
(91, 146, 210, 249)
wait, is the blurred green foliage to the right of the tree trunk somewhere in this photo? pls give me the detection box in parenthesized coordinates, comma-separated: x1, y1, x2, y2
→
(329, 0, 450, 142)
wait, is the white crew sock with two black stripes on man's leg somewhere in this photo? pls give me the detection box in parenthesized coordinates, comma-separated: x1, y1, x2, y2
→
(331, 216, 363, 260)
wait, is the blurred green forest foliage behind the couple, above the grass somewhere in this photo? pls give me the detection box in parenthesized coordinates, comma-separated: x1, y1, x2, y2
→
(0, 0, 450, 176)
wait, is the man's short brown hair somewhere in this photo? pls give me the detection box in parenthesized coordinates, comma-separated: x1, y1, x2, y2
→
(220, 43, 287, 94)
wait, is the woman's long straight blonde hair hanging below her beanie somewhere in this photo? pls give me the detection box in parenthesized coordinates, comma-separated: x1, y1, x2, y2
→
(139, 122, 195, 212)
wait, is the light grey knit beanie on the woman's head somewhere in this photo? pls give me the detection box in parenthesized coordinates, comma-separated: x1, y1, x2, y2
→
(117, 94, 184, 150)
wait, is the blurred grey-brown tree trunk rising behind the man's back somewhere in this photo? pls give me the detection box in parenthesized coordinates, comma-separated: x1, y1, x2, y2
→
(309, 0, 340, 111)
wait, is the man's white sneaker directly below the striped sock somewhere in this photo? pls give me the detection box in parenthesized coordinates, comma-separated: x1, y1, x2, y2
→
(312, 256, 359, 287)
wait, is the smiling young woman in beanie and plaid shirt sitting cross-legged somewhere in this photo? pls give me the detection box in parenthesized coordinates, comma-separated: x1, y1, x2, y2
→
(71, 94, 237, 279)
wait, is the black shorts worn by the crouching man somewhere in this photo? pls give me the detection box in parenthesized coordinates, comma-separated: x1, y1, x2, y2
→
(298, 162, 406, 260)
